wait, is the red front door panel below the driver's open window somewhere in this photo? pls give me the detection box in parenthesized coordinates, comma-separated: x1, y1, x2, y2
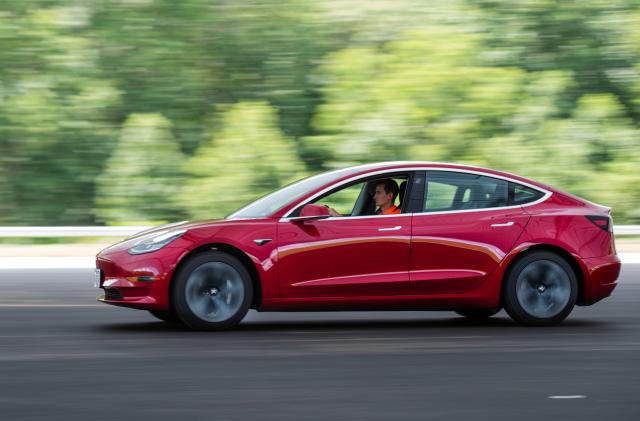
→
(278, 175, 411, 298)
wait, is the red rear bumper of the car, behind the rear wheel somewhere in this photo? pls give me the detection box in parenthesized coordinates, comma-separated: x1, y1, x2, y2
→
(578, 254, 621, 306)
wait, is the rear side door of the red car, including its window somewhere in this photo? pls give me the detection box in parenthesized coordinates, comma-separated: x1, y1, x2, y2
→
(410, 170, 529, 295)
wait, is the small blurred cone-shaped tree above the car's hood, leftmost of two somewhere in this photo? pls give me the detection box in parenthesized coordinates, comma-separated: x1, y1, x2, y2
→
(95, 114, 183, 224)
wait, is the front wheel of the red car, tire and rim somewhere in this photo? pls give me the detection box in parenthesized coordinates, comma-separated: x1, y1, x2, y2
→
(171, 251, 253, 330)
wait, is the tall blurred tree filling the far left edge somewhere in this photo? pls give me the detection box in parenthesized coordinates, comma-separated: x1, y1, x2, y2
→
(0, 1, 119, 225)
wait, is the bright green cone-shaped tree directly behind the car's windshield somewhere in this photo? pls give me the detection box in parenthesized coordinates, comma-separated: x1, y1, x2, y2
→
(176, 102, 304, 219)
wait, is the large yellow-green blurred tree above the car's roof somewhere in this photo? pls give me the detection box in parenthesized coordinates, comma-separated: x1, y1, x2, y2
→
(305, 27, 525, 166)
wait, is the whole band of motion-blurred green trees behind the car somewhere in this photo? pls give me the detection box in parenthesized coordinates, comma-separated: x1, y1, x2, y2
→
(0, 0, 640, 225)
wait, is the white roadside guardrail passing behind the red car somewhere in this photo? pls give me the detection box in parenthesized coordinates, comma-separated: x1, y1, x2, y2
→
(0, 225, 640, 238)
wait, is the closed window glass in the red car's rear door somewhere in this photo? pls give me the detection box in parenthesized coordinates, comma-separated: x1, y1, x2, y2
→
(424, 171, 509, 212)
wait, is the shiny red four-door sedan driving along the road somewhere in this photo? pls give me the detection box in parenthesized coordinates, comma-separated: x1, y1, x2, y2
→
(95, 162, 620, 330)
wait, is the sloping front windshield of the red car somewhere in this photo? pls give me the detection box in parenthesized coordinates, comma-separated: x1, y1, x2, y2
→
(227, 165, 380, 219)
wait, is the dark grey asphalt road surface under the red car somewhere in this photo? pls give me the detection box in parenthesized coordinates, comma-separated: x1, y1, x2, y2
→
(0, 265, 640, 421)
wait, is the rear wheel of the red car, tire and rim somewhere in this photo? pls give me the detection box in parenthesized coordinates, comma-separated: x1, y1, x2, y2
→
(503, 251, 578, 326)
